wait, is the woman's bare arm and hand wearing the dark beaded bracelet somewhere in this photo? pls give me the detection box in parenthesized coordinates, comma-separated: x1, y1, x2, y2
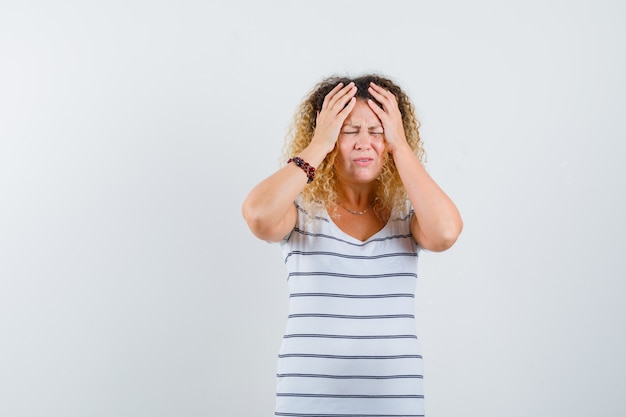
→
(242, 83, 356, 242)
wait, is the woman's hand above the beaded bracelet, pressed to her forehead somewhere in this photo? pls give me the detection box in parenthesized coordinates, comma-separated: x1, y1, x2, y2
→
(311, 82, 357, 154)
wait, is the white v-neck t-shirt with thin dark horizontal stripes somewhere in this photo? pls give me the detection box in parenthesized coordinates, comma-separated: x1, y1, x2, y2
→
(275, 202, 424, 417)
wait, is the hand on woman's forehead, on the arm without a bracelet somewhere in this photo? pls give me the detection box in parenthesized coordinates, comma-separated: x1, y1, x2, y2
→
(367, 83, 407, 153)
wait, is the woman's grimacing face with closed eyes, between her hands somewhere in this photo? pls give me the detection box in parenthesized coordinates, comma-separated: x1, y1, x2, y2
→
(334, 100, 386, 184)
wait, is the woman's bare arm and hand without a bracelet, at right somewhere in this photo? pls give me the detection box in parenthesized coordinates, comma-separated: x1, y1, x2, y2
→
(369, 84, 463, 252)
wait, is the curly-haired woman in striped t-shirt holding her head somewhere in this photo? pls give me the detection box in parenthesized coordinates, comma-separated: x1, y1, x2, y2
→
(242, 75, 462, 417)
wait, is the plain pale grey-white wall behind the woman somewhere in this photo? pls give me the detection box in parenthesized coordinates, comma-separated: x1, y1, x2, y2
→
(0, 0, 626, 417)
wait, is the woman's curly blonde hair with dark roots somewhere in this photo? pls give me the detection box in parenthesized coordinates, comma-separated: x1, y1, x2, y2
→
(283, 74, 425, 213)
